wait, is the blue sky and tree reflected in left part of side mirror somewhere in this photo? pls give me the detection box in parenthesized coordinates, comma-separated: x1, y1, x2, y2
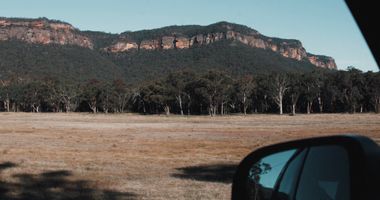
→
(247, 149, 296, 200)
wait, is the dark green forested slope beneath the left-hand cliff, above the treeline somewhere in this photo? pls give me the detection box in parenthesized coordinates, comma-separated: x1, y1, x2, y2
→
(0, 41, 123, 82)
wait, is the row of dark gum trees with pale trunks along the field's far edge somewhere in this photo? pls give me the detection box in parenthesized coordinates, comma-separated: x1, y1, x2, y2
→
(0, 68, 380, 116)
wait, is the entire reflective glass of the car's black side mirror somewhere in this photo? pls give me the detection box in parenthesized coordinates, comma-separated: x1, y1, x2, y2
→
(246, 145, 350, 200)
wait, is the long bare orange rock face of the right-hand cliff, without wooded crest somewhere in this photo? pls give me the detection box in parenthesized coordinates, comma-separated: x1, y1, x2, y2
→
(104, 25, 337, 69)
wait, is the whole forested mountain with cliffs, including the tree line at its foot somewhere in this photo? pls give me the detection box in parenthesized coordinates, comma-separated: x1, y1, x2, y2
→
(0, 18, 380, 116)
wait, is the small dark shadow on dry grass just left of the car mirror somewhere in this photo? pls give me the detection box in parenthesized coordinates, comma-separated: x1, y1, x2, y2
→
(172, 164, 237, 183)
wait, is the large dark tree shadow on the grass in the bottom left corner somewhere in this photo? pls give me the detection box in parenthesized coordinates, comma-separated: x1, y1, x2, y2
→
(0, 162, 137, 200)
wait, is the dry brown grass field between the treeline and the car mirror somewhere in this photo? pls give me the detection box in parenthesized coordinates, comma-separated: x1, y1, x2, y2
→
(0, 113, 380, 200)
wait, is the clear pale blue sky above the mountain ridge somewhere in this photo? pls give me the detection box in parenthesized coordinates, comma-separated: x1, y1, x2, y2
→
(0, 0, 378, 71)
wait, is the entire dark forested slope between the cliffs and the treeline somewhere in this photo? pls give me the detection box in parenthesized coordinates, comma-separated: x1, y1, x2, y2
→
(0, 41, 315, 83)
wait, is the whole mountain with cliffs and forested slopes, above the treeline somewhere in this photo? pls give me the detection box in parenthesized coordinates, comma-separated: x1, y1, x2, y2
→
(0, 18, 336, 82)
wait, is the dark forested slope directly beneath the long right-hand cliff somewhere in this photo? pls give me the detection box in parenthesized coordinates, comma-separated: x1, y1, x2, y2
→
(103, 41, 315, 81)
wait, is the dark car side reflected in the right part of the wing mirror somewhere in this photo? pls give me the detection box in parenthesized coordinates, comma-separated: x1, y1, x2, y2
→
(296, 145, 350, 200)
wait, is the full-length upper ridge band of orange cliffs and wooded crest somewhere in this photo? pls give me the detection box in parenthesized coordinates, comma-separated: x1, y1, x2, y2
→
(0, 17, 337, 69)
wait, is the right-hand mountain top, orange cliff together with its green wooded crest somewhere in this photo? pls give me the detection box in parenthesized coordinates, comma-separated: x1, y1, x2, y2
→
(98, 22, 336, 69)
